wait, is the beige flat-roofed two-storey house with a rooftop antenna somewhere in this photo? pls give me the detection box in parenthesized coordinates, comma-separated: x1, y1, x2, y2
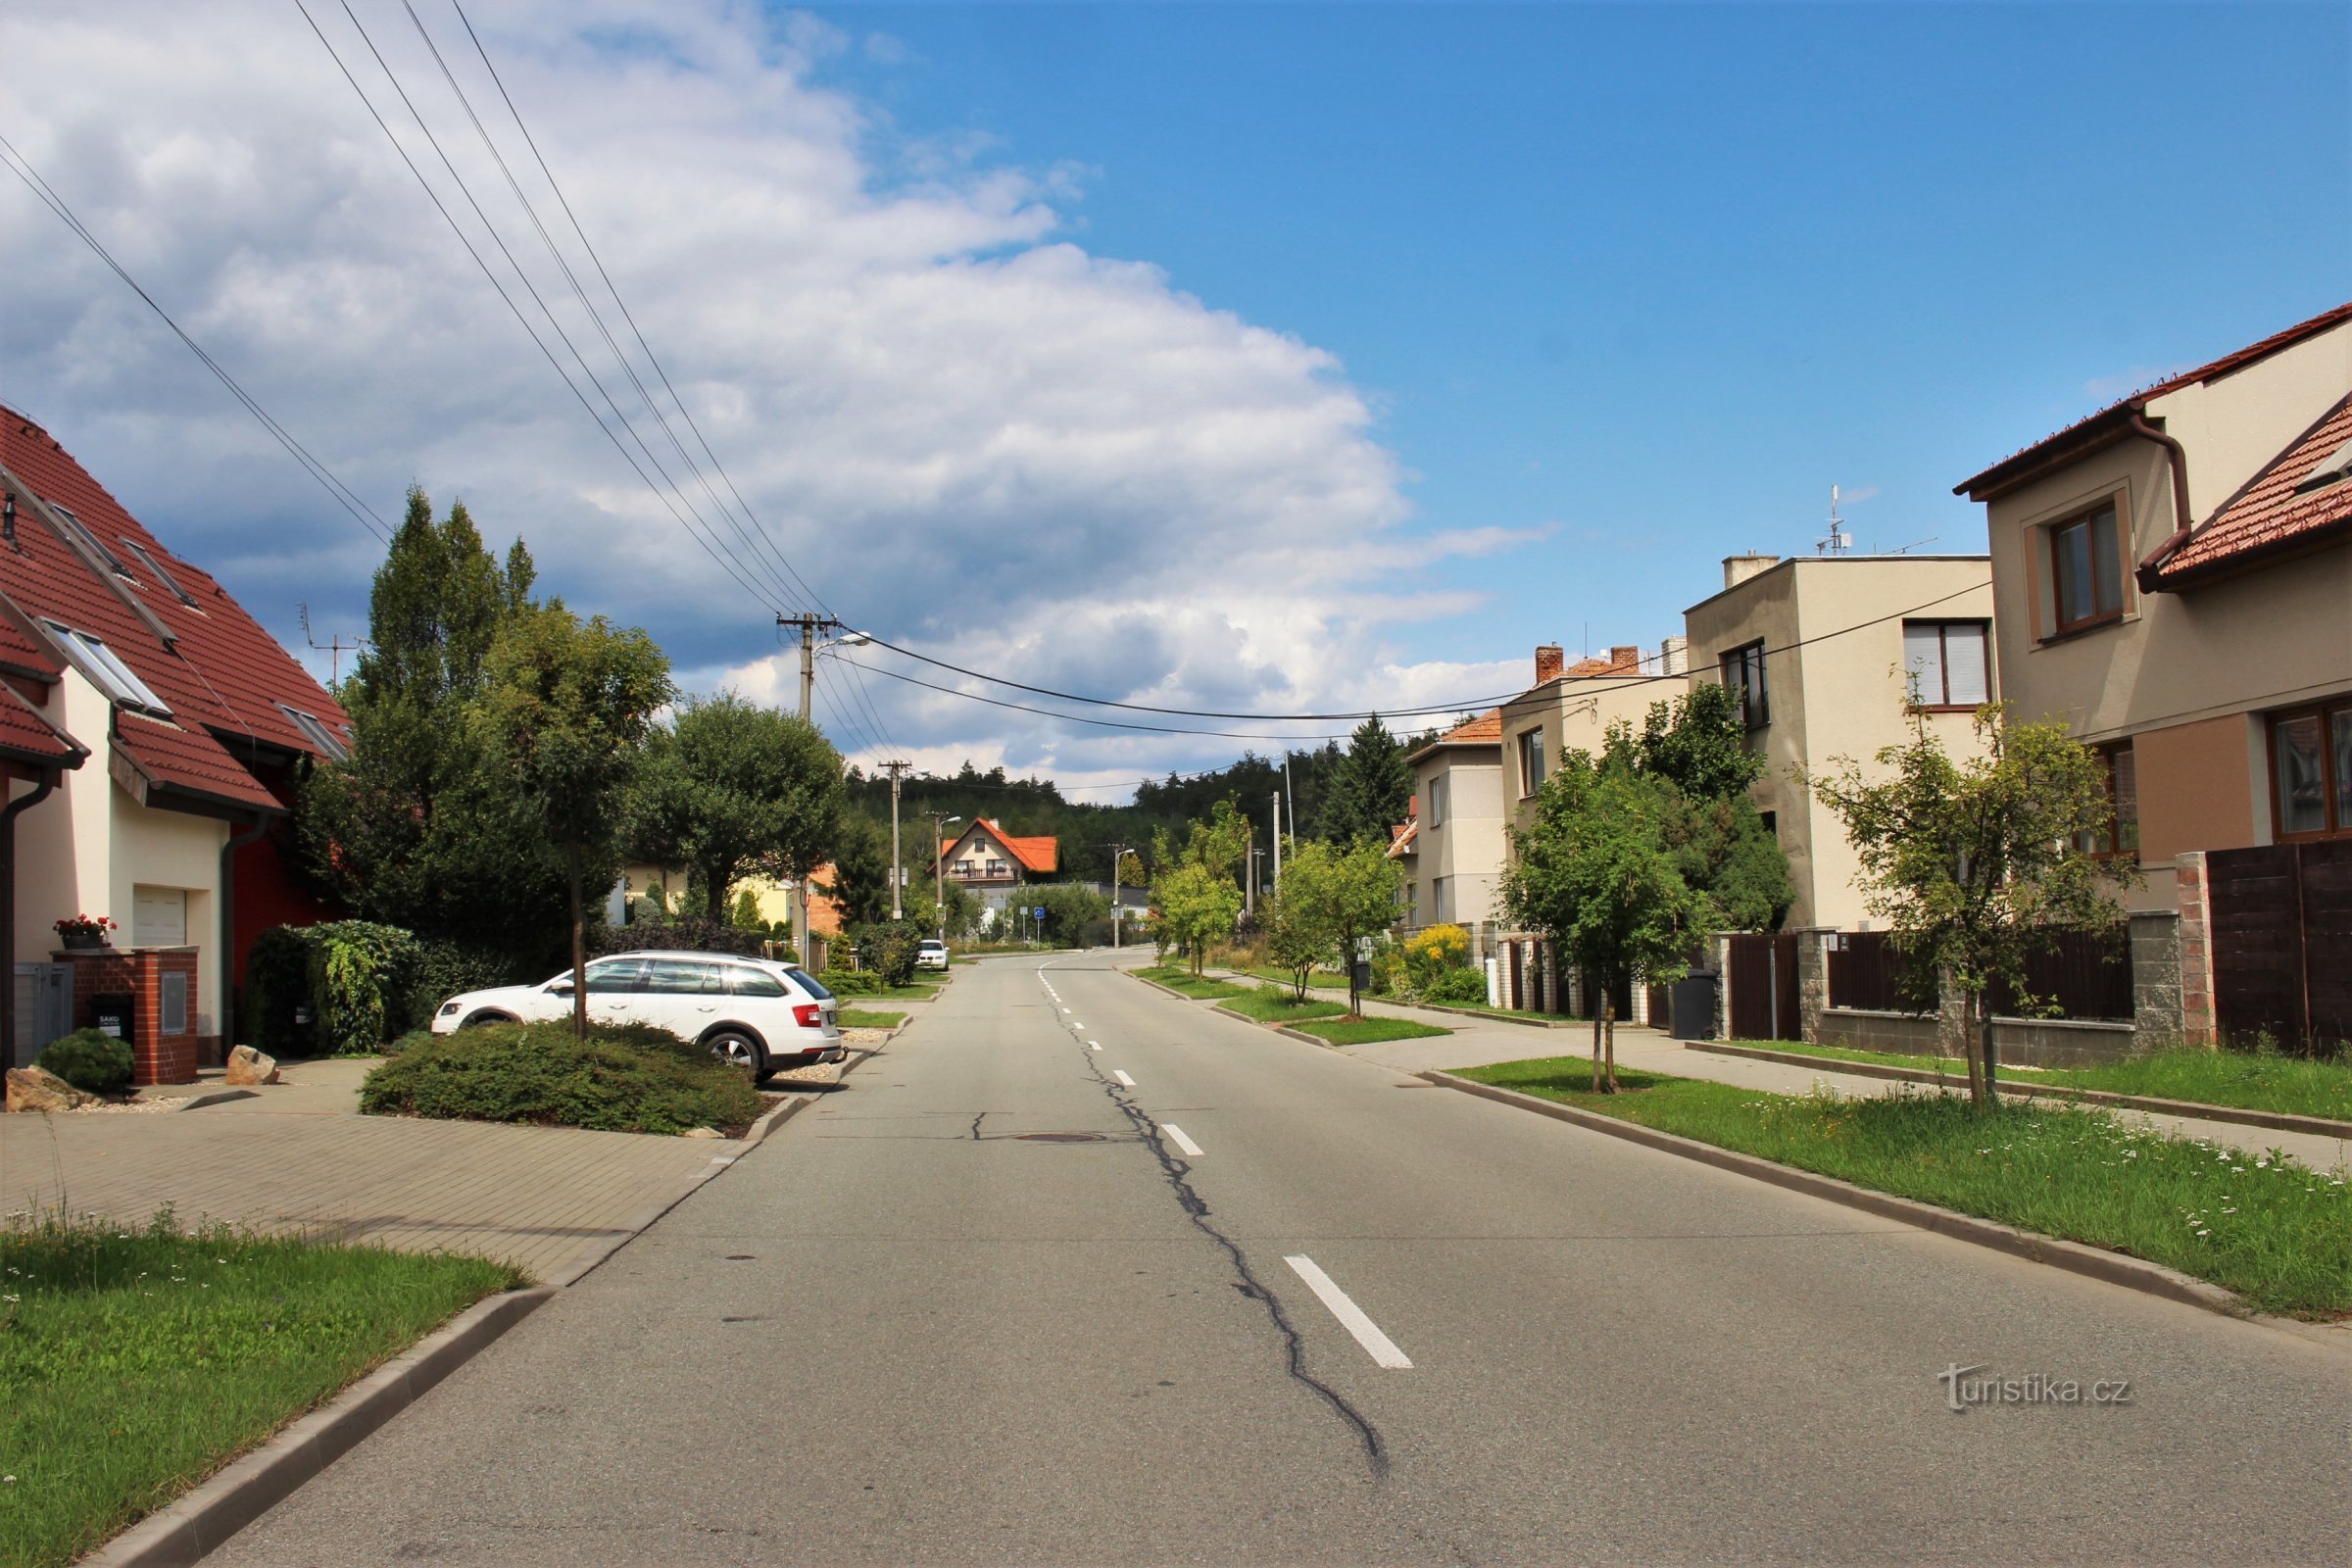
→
(1682, 555, 2001, 931)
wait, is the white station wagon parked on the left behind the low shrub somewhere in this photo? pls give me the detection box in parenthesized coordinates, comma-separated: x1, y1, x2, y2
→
(433, 953, 847, 1081)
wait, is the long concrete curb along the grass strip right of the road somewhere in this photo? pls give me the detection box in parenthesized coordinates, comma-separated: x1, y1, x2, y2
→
(1413, 1072, 2256, 1319)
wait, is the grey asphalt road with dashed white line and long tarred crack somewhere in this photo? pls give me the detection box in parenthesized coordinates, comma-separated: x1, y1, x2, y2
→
(217, 955, 2352, 1566)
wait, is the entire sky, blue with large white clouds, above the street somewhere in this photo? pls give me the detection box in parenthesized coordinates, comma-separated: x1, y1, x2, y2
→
(0, 0, 2352, 797)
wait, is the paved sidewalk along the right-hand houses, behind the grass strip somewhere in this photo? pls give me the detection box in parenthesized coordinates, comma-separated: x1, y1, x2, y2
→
(1213, 968, 2352, 1171)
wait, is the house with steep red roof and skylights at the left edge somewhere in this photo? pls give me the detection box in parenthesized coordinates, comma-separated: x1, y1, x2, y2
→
(0, 407, 351, 1081)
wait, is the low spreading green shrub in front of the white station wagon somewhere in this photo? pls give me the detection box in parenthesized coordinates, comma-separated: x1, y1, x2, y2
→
(360, 1022, 760, 1133)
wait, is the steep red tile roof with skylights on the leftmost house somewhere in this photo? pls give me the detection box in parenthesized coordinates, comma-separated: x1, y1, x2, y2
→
(0, 407, 351, 807)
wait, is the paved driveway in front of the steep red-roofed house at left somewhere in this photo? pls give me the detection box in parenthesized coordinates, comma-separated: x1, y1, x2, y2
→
(0, 1062, 800, 1281)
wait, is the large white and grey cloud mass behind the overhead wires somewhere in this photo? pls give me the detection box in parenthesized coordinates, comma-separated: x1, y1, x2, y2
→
(0, 0, 1541, 780)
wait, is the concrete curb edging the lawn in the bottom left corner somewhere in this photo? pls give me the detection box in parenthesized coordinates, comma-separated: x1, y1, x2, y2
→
(82, 1286, 555, 1568)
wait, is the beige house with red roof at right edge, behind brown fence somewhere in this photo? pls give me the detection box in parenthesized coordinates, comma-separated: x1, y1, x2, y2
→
(1954, 303, 2352, 909)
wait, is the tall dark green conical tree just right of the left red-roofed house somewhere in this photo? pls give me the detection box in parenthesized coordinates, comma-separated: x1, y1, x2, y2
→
(296, 487, 566, 964)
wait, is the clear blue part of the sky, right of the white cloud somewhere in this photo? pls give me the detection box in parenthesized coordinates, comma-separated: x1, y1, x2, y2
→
(818, 5, 2352, 656)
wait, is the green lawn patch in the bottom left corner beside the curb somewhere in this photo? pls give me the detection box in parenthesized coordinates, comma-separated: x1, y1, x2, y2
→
(0, 1210, 522, 1568)
